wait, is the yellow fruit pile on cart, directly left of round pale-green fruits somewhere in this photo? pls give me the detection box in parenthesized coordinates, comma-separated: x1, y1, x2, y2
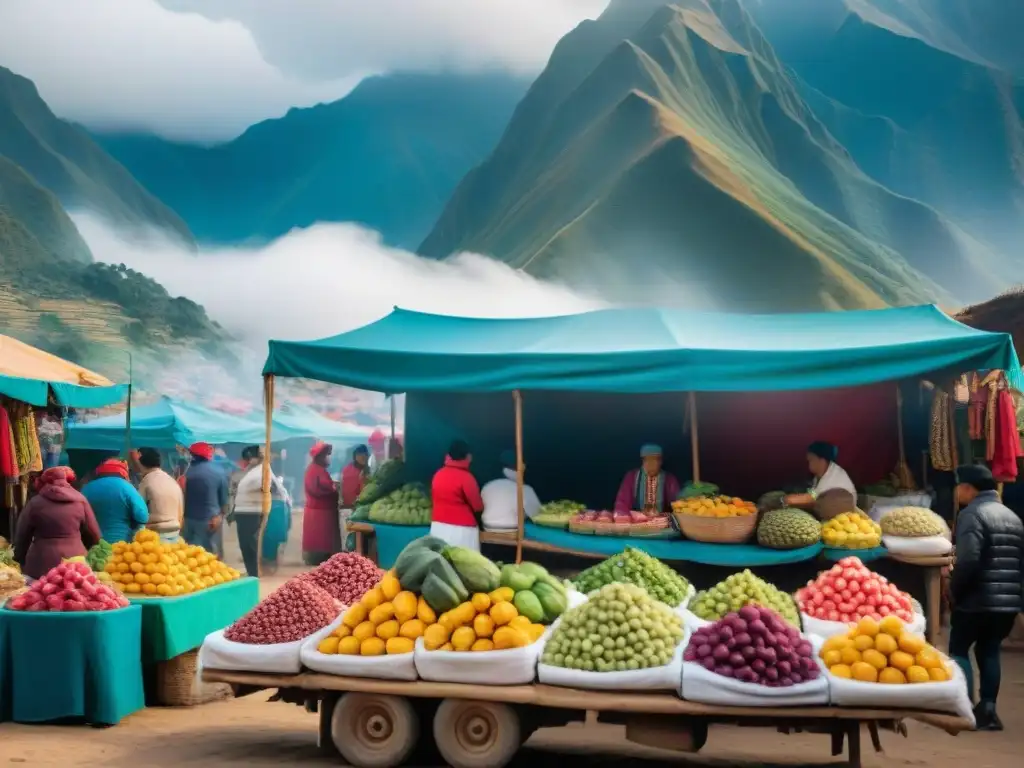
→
(423, 587, 545, 650)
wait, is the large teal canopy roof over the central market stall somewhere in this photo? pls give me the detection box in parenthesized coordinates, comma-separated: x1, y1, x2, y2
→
(263, 306, 1021, 393)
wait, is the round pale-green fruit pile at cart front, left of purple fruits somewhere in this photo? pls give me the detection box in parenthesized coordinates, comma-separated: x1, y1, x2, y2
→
(541, 584, 683, 672)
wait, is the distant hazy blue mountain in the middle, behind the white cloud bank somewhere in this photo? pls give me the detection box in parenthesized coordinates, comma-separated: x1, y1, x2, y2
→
(95, 74, 527, 248)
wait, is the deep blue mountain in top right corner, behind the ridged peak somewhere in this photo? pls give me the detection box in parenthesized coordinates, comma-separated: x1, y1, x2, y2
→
(750, 0, 1024, 260)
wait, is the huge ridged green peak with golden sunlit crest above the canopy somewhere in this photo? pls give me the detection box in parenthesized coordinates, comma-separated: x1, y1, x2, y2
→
(420, 0, 1004, 311)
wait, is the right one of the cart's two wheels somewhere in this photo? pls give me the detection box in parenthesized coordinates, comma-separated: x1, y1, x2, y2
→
(434, 698, 522, 768)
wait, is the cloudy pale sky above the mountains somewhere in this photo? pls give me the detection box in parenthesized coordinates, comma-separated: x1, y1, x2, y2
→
(0, 0, 608, 142)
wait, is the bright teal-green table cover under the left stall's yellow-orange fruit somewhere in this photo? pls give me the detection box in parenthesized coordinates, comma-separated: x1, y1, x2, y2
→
(128, 578, 259, 664)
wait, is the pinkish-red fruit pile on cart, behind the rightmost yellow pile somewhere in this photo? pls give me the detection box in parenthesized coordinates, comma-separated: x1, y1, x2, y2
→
(797, 557, 913, 624)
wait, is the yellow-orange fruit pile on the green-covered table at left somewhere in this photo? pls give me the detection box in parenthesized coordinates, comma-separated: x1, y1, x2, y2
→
(103, 528, 242, 597)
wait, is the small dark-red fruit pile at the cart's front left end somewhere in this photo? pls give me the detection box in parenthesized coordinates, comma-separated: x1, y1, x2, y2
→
(224, 579, 341, 645)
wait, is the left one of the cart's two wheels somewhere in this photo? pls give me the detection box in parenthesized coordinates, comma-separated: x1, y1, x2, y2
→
(331, 693, 420, 768)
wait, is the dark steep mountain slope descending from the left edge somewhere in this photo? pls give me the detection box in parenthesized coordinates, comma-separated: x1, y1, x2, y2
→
(0, 67, 193, 243)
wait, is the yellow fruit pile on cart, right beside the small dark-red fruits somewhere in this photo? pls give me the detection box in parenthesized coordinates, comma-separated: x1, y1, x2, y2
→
(316, 571, 419, 656)
